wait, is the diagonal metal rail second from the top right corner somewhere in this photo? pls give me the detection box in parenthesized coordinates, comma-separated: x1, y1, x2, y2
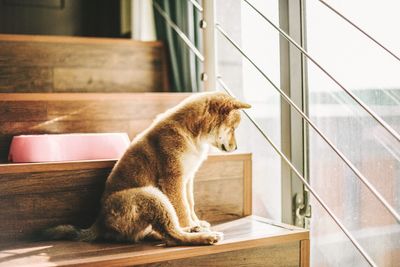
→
(243, 0, 400, 142)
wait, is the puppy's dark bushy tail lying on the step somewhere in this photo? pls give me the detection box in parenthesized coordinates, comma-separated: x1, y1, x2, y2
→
(39, 223, 100, 242)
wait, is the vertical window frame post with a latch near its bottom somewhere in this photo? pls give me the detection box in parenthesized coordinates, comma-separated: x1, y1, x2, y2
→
(279, 0, 310, 227)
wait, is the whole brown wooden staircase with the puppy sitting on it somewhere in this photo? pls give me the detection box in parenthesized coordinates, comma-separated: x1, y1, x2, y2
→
(0, 35, 309, 266)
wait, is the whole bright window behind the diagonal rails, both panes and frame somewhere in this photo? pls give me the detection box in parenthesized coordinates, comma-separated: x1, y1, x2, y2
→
(212, 0, 400, 266)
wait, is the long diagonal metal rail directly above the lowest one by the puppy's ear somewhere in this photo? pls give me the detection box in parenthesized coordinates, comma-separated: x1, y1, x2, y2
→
(215, 23, 400, 223)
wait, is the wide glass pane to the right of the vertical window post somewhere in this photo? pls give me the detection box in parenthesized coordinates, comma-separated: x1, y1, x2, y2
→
(306, 0, 400, 266)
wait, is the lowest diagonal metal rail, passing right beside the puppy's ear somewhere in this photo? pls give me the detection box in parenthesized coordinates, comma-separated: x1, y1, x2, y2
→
(217, 77, 377, 266)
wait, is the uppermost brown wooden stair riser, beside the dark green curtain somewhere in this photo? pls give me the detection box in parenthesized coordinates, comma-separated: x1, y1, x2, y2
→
(0, 34, 169, 93)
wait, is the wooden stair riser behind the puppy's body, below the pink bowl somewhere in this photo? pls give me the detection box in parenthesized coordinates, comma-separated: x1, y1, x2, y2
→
(0, 154, 251, 243)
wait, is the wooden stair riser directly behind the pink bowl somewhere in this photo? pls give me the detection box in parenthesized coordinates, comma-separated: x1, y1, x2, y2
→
(0, 93, 190, 163)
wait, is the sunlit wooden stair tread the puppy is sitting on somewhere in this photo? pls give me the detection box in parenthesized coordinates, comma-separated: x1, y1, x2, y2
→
(0, 216, 309, 266)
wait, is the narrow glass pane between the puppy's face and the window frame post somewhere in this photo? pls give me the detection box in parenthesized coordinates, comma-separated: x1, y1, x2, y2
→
(217, 0, 281, 220)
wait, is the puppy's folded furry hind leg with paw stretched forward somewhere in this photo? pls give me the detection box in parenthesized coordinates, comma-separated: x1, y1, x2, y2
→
(103, 187, 223, 245)
